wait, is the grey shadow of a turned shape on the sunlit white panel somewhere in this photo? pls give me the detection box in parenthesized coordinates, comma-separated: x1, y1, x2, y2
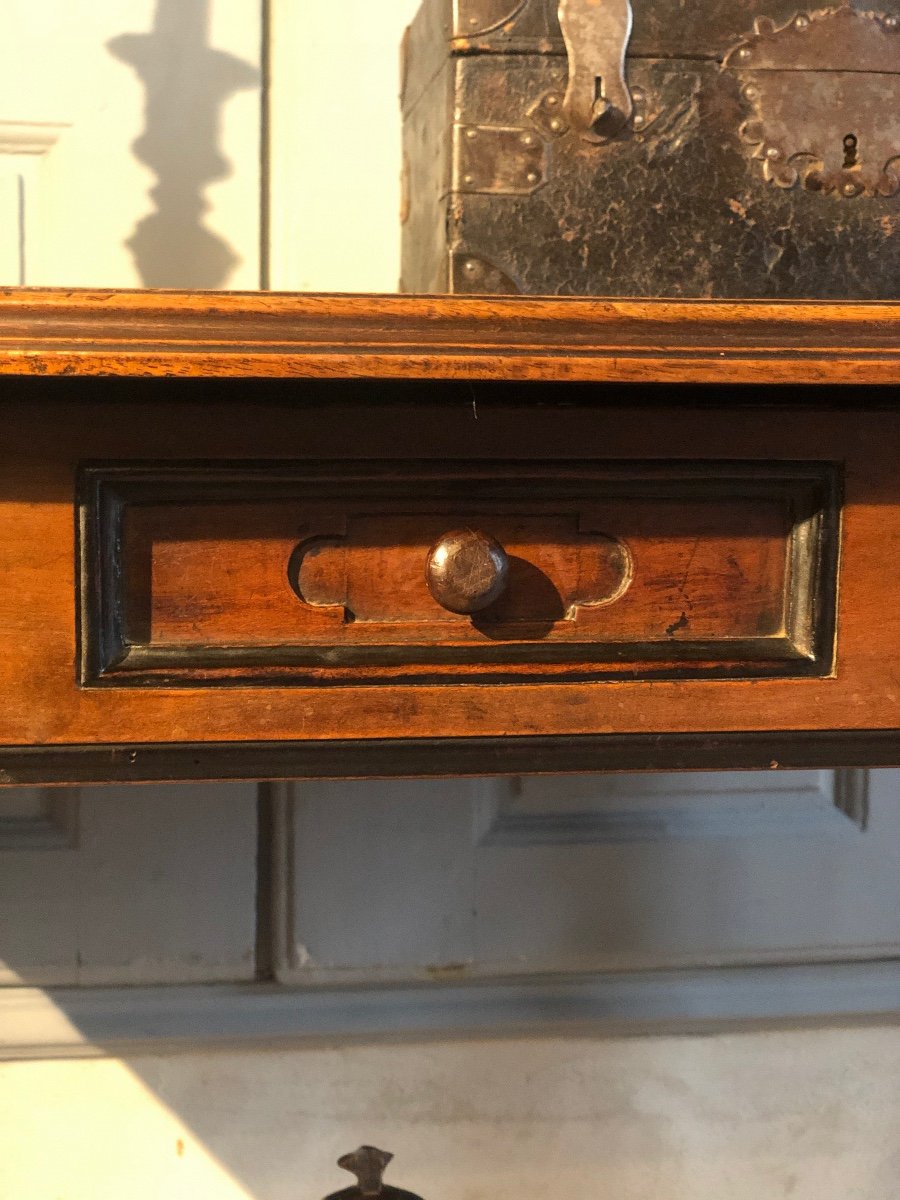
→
(107, 0, 259, 288)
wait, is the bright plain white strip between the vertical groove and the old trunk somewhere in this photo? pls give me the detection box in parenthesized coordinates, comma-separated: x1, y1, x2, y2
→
(269, 0, 420, 292)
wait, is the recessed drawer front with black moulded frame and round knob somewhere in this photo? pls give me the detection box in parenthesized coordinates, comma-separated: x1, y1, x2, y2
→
(78, 460, 840, 688)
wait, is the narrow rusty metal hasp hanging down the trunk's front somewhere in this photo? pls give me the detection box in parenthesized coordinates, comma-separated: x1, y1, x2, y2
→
(559, 0, 634, 143)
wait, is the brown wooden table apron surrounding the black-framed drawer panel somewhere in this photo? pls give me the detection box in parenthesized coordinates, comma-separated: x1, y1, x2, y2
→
(0, 391, 900, 745)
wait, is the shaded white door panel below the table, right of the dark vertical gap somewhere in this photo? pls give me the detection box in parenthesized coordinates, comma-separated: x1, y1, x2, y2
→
(277, 770, 900, 982)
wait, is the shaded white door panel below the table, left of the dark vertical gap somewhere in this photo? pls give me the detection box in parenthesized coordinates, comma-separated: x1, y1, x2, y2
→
(0, 784, 257, 985)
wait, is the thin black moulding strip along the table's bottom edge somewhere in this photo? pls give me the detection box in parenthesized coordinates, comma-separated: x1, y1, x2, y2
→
(0, 730, 900, 786)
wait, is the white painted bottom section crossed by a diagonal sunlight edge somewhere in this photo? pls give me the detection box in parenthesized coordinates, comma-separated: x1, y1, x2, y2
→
(0, 1028, 900, 1200)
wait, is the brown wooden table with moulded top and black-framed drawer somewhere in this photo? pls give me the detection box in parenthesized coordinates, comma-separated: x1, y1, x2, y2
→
(0, 285, 900, 782)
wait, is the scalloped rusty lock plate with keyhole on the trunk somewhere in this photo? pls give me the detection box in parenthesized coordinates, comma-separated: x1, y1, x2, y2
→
(724, 5, 900, 199)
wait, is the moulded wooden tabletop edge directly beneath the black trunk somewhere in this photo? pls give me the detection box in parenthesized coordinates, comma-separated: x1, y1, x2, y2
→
(0, 289, 900, 385)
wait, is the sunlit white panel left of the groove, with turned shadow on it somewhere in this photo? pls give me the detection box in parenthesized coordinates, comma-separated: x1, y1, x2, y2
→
(0, 0, 260, 288)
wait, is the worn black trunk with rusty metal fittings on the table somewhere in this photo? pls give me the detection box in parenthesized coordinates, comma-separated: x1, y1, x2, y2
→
(401, 0, 900, 300)
